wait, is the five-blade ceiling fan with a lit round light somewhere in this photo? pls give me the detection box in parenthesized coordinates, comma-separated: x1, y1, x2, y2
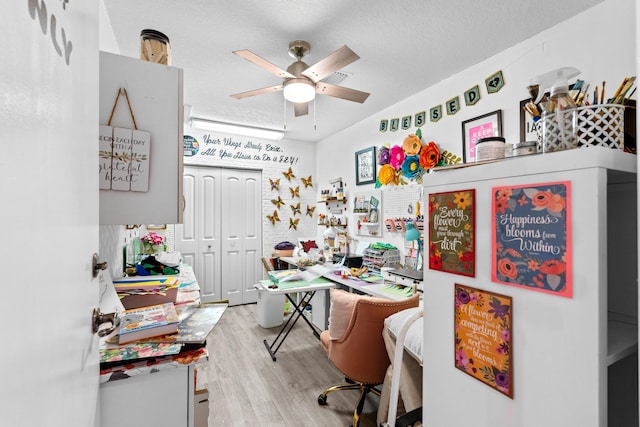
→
(231, 40, 369, 117)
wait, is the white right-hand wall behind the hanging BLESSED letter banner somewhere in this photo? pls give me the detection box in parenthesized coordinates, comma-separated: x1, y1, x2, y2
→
(317, 0, 637, 260)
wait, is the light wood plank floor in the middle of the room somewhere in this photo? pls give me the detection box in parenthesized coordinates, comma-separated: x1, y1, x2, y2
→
(198, 304, 378, 427)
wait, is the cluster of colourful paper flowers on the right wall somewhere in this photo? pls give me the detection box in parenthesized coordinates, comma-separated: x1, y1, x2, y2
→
(375, 129, 441, 188)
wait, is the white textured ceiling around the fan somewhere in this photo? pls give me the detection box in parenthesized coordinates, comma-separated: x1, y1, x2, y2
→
(103, 0, 602, 141)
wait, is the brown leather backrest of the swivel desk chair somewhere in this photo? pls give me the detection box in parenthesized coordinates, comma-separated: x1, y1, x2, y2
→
(328, 293, 419, 384)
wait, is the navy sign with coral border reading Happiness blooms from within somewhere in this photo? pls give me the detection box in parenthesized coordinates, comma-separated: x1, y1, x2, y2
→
(491, 181, 572, 298)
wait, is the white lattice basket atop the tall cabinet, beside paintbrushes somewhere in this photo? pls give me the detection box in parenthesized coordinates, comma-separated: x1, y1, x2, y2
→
(536, 104, 624, 152)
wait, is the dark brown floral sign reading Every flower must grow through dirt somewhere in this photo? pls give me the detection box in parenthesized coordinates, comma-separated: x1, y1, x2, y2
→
(429, 189, 476, 277)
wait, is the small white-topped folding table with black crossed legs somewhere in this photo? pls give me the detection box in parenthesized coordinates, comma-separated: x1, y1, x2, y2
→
(256, 277, 336, 362)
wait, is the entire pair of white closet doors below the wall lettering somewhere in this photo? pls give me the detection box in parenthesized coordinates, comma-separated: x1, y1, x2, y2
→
(175, 166, 262, 305)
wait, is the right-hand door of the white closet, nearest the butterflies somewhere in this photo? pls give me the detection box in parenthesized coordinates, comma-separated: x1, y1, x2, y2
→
(221, 169, 262, 305)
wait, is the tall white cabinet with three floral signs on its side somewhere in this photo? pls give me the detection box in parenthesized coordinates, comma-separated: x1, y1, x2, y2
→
(423, 147, 638, 427)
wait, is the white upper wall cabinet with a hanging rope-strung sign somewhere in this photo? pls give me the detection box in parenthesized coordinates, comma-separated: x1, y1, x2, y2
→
(96, 52, 184, 224)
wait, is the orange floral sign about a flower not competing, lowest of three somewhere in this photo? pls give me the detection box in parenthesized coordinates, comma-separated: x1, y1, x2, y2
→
(453, 284, 513, 399)
